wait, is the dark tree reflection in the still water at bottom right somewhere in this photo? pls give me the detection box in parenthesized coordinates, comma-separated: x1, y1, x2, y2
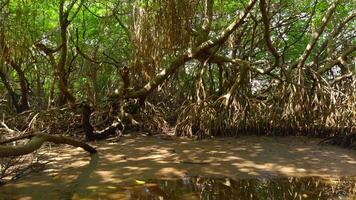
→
(128, 177, 356, 199)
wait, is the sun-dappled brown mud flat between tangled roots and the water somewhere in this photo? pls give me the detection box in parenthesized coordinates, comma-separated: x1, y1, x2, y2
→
(0, 135, 356, 199)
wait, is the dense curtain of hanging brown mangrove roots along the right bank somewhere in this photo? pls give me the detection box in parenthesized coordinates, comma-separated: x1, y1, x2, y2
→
(176, 79, 356, 141)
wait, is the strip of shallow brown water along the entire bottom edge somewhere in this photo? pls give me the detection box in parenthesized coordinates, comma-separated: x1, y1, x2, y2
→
(5, 177, 356, 200)
